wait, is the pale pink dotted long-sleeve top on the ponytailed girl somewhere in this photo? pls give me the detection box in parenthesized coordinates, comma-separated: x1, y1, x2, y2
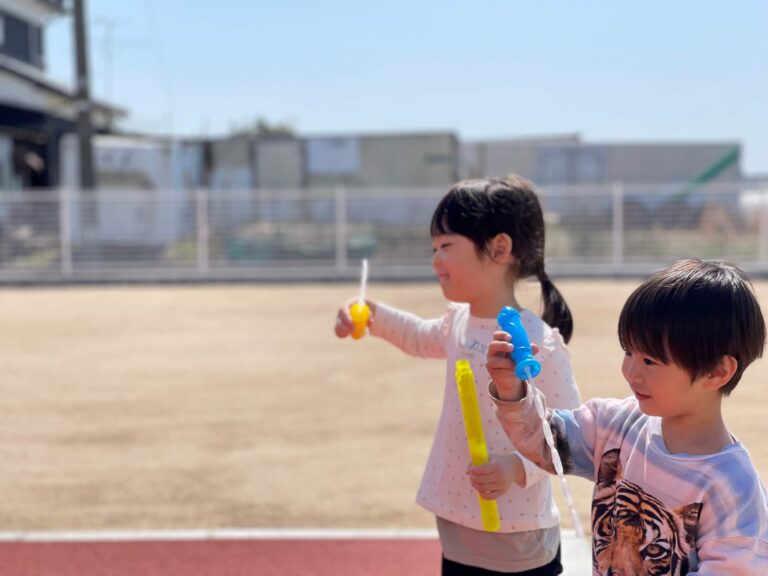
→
(370, 303, 579, 532)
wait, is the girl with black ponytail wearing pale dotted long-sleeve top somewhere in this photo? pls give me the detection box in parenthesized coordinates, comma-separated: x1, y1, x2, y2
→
(335, 176, 579, 576)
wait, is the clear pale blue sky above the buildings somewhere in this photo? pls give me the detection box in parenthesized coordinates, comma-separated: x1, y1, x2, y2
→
(46, 0, 768, 174)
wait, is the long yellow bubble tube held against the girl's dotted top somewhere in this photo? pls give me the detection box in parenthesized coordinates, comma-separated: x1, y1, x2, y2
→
(456, 360, 501, 532)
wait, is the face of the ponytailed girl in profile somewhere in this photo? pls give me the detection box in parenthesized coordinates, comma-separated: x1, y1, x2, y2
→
(432, 234, 488, 304)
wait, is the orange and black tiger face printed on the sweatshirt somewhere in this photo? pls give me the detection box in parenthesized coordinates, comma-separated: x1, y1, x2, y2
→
(592, 449, 701, 576)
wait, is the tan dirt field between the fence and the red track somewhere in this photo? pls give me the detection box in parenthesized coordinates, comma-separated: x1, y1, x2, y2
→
(0, 280, 768, 531)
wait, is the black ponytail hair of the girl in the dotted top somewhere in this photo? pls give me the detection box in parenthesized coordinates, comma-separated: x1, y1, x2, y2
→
(430, 176, 573, 342)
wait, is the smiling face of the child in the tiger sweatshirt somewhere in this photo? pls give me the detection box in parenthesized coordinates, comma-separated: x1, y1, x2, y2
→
(621, 350, 701, 417)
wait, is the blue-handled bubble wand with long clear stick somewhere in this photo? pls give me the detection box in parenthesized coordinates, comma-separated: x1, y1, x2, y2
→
(497, 306, 584, 538)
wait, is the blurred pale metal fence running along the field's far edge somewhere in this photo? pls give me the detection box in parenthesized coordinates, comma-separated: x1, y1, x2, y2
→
(0, 181, 768, 283)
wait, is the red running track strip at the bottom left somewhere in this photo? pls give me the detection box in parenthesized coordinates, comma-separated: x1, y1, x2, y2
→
(0, 538, 440, 576)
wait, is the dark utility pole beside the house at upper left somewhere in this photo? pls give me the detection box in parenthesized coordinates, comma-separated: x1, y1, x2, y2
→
(74, 0, 98, 204)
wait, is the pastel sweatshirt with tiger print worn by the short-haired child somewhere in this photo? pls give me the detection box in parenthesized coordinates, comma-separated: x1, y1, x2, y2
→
(489, 384, 768, 576)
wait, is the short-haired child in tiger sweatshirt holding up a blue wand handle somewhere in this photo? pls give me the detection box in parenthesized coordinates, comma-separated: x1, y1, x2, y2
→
(487, 260, 768, 576)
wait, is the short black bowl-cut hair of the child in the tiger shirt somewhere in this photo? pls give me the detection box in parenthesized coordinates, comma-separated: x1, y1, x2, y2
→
(619, 259, 765, 396)
